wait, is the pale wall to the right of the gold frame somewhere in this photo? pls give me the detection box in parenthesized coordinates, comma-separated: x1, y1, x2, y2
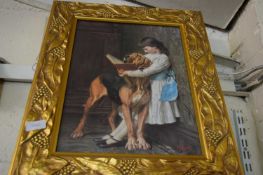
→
(229, 0, 263, 167)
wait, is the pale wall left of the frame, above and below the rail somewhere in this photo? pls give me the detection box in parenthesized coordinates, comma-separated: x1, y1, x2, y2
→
(0, 0, 49, 175)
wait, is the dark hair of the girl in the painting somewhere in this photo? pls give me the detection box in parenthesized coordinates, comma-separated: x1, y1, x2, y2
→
(139, 37, 169, 56)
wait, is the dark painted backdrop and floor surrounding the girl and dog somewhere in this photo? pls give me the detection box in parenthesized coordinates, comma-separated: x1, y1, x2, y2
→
(57, 21, 201, 155)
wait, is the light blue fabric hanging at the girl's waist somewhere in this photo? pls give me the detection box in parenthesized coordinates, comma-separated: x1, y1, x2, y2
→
(160, 70, 178, 101)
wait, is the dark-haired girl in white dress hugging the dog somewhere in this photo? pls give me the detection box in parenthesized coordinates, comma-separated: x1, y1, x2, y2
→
(99, 37, 180, 149)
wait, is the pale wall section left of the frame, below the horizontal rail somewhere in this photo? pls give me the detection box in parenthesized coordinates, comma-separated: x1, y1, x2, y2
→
(0, 82, 31, 174)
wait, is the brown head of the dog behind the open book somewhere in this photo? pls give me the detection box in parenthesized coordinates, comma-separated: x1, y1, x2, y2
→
(126, 52, 152, 69)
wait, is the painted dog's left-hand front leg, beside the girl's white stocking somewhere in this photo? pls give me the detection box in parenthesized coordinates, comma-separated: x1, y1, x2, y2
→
(120, 87, 137, 150)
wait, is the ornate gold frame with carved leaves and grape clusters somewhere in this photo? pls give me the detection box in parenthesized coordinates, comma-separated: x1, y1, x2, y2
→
(10, 1, 244, 175)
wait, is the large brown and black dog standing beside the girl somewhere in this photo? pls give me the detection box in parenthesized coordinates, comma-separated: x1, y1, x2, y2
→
(71, 53, 151, 150)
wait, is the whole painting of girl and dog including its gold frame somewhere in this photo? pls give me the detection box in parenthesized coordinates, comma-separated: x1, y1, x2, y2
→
(10, 1, 243, 174)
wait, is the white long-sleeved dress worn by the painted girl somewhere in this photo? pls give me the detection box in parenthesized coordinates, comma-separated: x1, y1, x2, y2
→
(127, 53, 180, 125)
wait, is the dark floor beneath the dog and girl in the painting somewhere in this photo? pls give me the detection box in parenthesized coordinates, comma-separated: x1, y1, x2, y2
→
(57, 110, 200, 155)
